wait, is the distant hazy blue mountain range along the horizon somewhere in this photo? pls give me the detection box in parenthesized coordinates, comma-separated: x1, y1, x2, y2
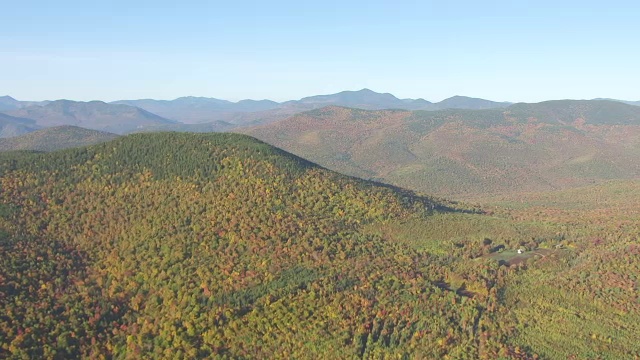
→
(0, 89, 640, 136)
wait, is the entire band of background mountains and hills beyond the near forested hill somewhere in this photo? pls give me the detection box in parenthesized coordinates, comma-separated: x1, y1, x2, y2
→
(0, 89, 640, 197)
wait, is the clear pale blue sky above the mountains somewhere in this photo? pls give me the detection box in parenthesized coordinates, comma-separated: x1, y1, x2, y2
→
(0, 0, 640, 102)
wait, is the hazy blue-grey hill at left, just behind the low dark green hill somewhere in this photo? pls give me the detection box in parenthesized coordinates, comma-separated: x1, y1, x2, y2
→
(9, 100, 175, 134)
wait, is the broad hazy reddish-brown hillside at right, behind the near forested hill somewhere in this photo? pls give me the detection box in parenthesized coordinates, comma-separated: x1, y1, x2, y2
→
(244, 100, 640, 197)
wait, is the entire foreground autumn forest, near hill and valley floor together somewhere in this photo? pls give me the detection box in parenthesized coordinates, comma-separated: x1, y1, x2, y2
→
(0, 133, 640, 359)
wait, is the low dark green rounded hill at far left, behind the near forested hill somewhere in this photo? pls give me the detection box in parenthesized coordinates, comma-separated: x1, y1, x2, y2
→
(0, 125, 118, 151)
